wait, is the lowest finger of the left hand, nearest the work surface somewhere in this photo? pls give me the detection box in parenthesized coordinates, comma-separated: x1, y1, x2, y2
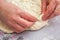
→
(9, 22, 24, 33)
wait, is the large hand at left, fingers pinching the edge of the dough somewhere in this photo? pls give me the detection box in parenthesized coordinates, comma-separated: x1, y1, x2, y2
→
(0, 1, 37, 33)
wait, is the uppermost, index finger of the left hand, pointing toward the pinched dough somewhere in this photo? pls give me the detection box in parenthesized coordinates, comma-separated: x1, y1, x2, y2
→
(18, 10, 37, 22)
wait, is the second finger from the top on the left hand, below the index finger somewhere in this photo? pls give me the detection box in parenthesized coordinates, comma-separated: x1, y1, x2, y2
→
(14, 17, 34, 29)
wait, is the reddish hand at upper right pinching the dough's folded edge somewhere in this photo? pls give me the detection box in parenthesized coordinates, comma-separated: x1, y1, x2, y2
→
(42, 0, 60, 20)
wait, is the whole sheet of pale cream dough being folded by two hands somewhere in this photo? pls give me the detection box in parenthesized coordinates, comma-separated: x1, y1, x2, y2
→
(0, 0, 48, 33)
